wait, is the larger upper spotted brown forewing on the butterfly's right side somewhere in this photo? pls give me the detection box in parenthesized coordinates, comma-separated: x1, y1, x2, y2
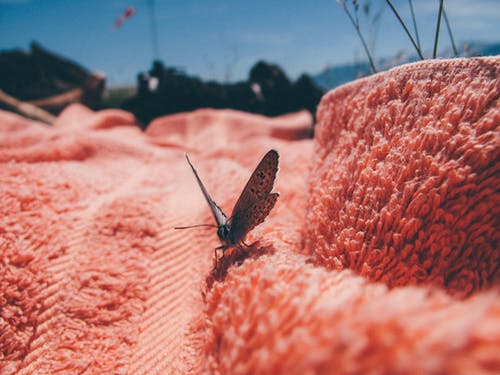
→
(231, 150, 279, 222)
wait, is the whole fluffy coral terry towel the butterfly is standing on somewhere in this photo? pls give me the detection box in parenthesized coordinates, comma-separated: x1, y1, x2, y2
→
(0, 58, 500, 374)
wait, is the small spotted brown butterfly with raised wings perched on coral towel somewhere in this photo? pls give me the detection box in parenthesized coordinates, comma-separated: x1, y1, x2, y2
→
(175, 150, 279, 252)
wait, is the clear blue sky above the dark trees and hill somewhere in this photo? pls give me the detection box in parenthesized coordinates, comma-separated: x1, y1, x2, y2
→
(0, 0, 500, 86)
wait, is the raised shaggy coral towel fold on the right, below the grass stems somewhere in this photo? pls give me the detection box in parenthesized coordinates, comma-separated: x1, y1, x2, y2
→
(304, 59, 500, 295)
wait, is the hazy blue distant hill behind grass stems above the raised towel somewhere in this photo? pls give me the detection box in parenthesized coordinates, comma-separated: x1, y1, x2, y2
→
(312, 42, 500, 90)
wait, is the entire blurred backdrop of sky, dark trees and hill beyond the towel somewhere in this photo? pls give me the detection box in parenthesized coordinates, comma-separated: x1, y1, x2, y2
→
(0, 0, 500, 127)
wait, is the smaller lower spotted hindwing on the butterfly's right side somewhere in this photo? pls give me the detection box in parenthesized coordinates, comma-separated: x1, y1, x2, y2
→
(230, 193, 279, 243)
